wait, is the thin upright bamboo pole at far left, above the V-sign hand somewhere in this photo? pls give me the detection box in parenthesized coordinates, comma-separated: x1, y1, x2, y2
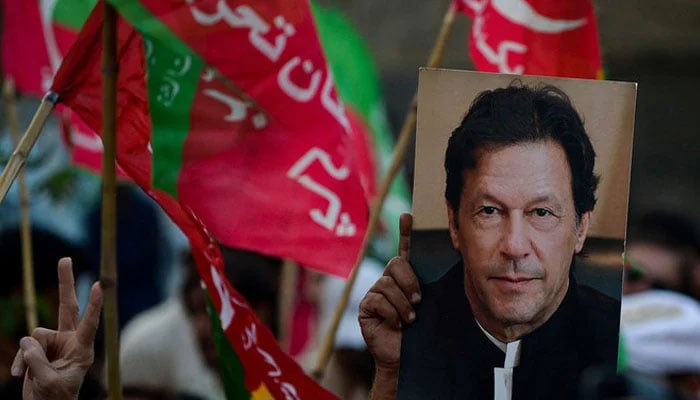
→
(3, 79, 39, 334)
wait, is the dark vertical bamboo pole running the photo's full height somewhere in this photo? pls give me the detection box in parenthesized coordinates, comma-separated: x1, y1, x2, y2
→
(100, 3, 122, 400)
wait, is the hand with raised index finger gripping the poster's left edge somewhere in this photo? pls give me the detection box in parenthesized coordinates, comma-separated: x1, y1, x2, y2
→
(358, 214, 421, 400)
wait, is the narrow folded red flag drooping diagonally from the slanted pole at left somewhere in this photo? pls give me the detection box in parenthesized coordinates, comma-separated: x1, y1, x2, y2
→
(52, 3, 334, 399)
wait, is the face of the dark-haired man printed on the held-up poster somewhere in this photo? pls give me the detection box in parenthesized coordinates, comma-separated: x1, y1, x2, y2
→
(448, 141, 590, 341)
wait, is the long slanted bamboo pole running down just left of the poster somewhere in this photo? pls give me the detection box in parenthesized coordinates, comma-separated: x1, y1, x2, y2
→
(312, 2, 456, 380)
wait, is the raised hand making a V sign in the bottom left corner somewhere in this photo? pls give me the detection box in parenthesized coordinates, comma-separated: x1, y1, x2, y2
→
(11, 258, 102, 400)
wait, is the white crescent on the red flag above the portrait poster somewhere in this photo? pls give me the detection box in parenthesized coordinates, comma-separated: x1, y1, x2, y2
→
(491, 0, 586, 33)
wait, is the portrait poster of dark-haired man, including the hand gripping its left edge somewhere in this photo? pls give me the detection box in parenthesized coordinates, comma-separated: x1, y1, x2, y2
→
(360, 70, 636, 400)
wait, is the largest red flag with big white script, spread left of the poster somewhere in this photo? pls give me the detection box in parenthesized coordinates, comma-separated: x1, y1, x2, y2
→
(113, 0, 368, 276)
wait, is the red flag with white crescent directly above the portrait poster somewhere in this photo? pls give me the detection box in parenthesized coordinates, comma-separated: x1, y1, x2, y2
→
(454, 0, 603, 79)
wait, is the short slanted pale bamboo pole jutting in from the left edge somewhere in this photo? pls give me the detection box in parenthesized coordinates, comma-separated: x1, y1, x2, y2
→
(0, 92, 58, 204)
